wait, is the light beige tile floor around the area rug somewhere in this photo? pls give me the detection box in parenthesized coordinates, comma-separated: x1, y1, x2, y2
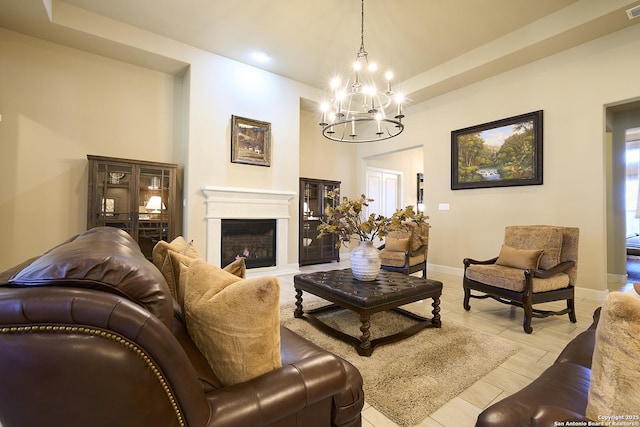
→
(280, 261, 602, 427)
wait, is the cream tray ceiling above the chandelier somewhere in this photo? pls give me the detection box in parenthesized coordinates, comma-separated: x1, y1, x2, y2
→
(0, 0, 640, 101)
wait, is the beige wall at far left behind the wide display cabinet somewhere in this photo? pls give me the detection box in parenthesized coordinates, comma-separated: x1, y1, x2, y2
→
(0, 29, 182, 270)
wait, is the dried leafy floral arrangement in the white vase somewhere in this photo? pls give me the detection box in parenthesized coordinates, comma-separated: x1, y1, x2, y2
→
(318, 190, 429, 248)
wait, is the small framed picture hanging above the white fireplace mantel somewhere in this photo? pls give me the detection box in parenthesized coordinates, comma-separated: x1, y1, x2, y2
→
(231, 116, 271, 167)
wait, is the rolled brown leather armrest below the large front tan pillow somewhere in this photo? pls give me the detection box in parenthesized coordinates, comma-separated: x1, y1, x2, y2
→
(207, 353, 347, 427)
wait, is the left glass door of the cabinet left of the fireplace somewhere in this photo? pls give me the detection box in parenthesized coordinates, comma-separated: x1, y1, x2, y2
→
(94, 163, 134, 233)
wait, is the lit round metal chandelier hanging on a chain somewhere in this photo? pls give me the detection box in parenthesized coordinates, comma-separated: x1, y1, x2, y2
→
(319, 0, 404, 142)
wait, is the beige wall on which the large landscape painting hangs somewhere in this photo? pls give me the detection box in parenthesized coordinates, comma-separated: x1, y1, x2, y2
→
(359, 25, 640, 298)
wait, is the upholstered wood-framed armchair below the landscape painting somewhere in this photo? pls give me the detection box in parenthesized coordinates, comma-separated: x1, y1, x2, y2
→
(462, 225, 579, 334)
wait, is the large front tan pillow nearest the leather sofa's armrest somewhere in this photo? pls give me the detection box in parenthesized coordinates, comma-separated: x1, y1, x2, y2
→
(181, 259, 282, 386)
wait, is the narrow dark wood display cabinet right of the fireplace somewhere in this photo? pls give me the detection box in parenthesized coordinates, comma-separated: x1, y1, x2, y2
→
(298, 178, 340, 265)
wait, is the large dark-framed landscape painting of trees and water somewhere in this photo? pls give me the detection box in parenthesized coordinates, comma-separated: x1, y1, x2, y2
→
(451, 110, 542, 190)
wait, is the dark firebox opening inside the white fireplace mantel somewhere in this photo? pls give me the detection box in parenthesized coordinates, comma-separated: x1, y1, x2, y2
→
(220, 219, 276, 269)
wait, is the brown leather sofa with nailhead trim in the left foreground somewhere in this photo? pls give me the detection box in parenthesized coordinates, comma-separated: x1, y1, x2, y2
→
(0, 228, 364, 427)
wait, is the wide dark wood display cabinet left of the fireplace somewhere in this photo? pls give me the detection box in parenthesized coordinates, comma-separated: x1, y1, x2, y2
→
(87, 155, 179, 259)
